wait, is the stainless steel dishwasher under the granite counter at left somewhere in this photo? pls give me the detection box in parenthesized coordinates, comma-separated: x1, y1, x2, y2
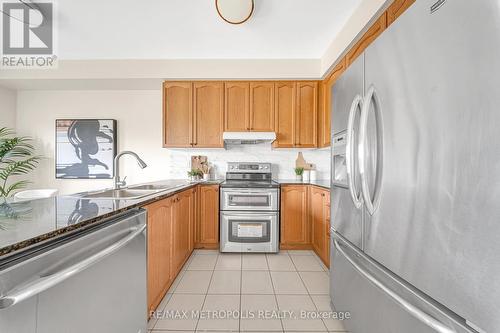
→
(0, 209, 147, 333)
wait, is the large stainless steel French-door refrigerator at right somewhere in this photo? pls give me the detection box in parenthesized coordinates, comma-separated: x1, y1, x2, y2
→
(330, 0, 500, 333)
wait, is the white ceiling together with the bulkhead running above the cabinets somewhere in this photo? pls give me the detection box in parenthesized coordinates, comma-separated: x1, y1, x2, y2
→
(0, 0, 393, 90)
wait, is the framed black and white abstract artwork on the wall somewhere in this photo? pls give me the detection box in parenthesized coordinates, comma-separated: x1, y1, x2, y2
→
(56, 119, 116, 179)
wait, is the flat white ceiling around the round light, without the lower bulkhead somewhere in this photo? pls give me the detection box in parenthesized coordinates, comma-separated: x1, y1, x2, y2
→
(56, 0, 361, 60)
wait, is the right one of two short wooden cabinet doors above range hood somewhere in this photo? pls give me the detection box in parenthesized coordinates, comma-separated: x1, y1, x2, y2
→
(250, 82, 274, 132)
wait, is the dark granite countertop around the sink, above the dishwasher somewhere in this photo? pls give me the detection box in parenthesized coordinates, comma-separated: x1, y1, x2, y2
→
(0, 180, 222, 262)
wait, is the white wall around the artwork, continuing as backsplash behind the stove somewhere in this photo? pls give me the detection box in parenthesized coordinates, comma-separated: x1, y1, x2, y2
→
(17, 90, 329, 194)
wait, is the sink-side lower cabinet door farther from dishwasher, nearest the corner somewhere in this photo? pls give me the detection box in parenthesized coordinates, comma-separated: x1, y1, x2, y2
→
(172, 189, 194, 275)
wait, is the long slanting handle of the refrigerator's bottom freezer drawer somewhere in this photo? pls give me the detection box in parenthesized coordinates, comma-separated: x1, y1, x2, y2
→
(333, 234, 455, 333)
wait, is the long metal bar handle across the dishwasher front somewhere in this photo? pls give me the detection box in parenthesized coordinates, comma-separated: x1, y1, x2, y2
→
(0, 224, 146, 310)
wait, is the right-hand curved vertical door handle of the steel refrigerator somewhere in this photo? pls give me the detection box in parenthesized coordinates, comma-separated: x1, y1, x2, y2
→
(358, 85, 384, 215)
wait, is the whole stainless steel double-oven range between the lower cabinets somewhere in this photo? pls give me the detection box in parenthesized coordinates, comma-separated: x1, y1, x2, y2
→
(220, 163, 280, 252)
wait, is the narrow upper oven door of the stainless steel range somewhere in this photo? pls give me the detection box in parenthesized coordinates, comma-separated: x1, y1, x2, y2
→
(221, 188, 279, 211)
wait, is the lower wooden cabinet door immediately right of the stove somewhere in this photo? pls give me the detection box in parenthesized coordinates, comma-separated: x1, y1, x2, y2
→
(280, 185, 310, 248)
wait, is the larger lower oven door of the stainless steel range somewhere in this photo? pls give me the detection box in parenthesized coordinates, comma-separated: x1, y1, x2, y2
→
(220, 212, 279, 252)
